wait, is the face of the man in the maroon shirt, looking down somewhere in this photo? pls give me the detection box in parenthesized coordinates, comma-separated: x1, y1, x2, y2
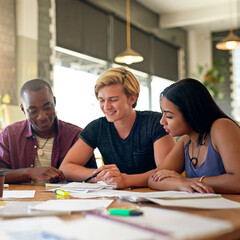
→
(21, 87, 56, 138)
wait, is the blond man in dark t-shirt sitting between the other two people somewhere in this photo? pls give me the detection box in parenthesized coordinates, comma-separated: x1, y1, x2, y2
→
(60, 67, 175, 188)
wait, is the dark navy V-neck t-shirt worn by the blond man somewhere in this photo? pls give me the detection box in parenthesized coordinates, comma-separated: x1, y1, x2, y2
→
(80, 111, 167, 174)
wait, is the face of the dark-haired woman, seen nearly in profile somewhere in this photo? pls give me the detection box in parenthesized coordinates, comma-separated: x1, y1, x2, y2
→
(160, 97, 192, 137)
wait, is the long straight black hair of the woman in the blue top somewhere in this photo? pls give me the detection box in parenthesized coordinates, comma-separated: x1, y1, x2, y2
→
(160, 78, 233, 145)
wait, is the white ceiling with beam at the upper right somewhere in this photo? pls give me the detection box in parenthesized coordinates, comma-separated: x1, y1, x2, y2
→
(137, 0, 240, 31)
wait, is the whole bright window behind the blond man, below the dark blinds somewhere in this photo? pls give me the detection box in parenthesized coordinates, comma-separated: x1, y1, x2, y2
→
(54, 47, 172, 124)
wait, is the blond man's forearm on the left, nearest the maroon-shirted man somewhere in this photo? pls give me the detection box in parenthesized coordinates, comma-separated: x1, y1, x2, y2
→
(59, 163, 96, 182)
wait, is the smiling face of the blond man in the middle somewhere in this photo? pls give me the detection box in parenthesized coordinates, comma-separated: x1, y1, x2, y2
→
(98, 84, 136, 122)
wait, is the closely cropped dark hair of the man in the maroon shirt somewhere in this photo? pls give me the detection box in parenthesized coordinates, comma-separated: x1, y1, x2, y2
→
(20, 79, 53, 99)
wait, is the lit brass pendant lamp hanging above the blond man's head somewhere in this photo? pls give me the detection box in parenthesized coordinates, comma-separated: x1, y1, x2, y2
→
(114, 0, 143, 65)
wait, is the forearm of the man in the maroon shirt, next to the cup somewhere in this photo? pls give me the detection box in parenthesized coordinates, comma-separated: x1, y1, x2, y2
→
(1, 168, 31, 183)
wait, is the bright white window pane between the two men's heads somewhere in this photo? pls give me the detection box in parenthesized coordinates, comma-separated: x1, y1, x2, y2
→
(54, 66, 103, 128)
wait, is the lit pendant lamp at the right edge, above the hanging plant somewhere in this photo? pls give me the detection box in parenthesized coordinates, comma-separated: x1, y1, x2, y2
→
(216, 0, 240, 50)
